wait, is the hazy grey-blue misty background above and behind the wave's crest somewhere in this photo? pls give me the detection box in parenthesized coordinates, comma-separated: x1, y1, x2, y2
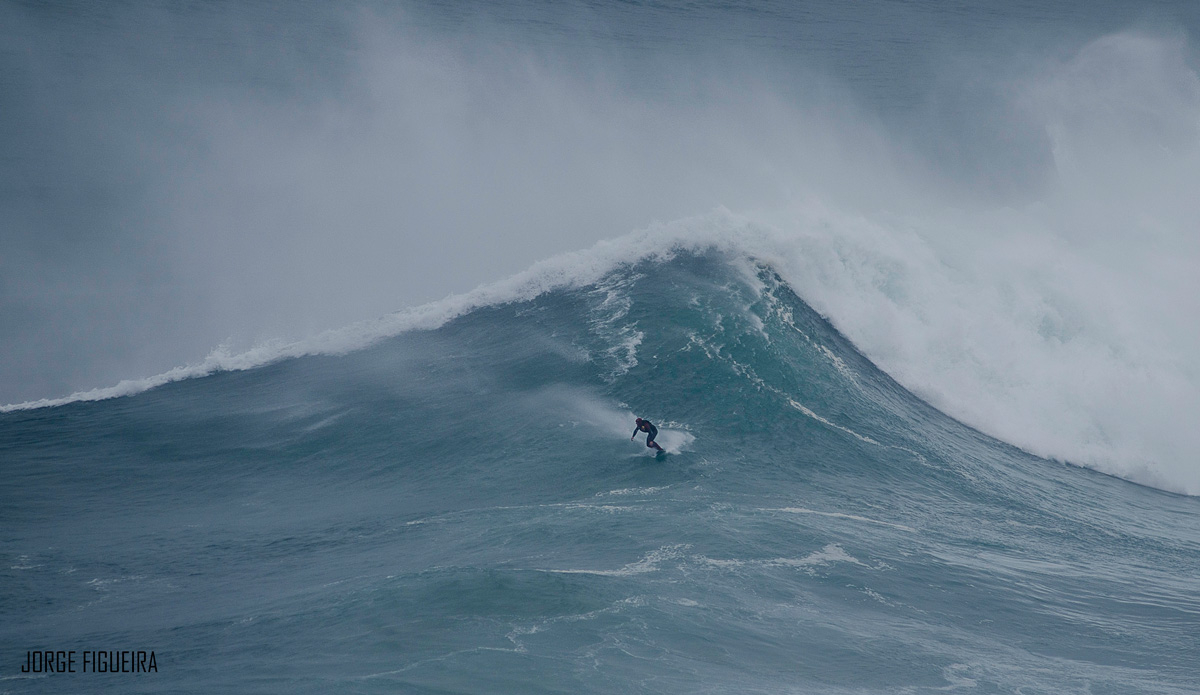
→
(0, 0, 1200, 403)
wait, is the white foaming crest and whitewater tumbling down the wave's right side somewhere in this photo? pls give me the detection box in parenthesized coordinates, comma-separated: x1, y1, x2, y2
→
(0, 198, 1200, 495)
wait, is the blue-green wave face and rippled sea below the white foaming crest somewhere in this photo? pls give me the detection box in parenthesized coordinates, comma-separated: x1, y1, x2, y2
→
(0, 250, 1200, 694)
